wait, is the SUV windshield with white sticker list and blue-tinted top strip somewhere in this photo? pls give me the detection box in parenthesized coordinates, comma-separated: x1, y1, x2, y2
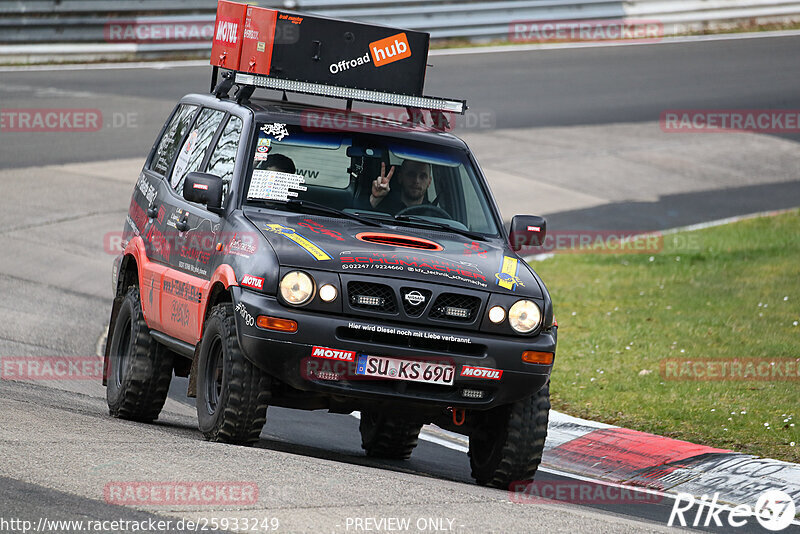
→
(245, 123, 498, 235)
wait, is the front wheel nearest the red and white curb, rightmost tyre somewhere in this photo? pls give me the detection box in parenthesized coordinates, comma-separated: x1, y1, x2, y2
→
(469, 384, 550, 489)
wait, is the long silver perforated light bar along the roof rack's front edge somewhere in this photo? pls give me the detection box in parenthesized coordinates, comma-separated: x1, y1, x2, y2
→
(235, 72, 467, 114)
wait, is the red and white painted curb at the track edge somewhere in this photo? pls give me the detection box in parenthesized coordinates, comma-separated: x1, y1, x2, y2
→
(420, 410, 800, 516)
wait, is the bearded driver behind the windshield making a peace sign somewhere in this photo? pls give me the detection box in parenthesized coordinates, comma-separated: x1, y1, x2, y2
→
(369, 159, 431, 215)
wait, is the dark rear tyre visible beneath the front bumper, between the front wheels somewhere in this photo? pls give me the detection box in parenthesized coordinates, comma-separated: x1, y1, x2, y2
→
(358, 412, 422, 460)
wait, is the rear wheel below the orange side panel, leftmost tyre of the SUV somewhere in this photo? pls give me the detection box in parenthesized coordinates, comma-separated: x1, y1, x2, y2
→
(106, 287, 173, 421)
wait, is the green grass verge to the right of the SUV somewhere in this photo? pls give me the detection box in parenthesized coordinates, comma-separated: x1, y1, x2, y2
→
(532, 210, 800, 462)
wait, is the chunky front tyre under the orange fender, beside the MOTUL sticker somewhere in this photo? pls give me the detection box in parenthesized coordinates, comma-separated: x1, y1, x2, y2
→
(196, 303, 269, 445)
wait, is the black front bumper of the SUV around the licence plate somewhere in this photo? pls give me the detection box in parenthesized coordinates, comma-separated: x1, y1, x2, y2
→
(232, 287, 556, 410)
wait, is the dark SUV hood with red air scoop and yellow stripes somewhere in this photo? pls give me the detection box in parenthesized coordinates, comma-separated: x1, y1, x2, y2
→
(246, 211, 543, 298)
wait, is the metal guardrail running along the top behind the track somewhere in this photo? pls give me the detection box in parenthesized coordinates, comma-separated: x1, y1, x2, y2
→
(0, 0, 800, 63)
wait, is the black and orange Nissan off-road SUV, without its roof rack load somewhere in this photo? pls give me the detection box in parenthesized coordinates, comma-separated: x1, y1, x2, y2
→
(105, 6, 557, 486)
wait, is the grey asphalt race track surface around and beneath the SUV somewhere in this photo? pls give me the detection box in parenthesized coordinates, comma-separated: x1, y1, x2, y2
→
(0, 34, 800, 532)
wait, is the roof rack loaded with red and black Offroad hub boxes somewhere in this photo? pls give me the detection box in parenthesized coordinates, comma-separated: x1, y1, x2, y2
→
(211, 0, 467, 117)
